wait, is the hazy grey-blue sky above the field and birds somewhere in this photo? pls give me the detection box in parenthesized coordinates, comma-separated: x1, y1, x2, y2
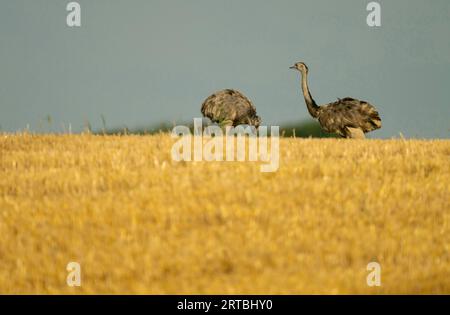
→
(0, 0, 450, 138)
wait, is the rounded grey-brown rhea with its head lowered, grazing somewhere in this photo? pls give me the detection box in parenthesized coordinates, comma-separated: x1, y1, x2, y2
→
(202, 89, 261, 128)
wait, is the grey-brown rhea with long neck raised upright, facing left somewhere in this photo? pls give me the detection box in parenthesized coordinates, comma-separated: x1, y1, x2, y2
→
(290, 62, 381, 139)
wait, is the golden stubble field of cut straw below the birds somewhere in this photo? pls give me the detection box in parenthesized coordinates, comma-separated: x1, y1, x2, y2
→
(0, 134, 450, 294)
